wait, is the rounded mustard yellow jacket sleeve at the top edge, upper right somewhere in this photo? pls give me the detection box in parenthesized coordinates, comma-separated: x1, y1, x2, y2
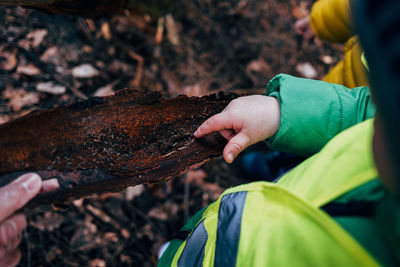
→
(310, 0, 355, 43)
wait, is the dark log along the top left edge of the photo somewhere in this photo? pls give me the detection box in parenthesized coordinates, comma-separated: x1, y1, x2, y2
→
(0, 0, 172, 17)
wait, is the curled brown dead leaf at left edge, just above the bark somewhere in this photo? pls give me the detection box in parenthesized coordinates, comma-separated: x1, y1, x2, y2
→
(3, 86, 40, 111)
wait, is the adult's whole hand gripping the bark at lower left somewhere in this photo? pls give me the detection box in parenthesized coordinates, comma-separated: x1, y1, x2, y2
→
(0, 173, 59, 267)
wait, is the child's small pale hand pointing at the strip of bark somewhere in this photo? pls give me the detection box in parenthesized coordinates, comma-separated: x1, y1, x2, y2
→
(194, 95, 280, 163)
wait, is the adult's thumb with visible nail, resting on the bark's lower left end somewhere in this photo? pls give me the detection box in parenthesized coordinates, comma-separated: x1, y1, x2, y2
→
(0, 173, 42, 222)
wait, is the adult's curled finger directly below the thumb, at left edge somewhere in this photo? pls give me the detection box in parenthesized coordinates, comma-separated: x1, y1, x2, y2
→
(0, 213, 26, 248)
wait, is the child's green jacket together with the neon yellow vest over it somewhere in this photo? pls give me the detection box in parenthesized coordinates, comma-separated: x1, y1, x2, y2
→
(158, 74, 400, 267)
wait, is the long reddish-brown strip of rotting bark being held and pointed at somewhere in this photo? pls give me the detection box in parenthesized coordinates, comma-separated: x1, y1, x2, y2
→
(0, 90, 234, 207)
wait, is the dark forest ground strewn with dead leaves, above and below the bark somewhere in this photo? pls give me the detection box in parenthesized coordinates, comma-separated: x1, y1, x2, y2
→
(0, 0, 342, 266)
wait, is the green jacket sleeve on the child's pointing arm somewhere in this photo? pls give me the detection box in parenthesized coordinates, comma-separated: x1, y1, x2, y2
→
(266, 74, 375, 156)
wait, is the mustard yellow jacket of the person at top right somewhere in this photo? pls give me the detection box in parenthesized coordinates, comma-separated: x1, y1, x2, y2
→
(310, 0, 368, 88)
